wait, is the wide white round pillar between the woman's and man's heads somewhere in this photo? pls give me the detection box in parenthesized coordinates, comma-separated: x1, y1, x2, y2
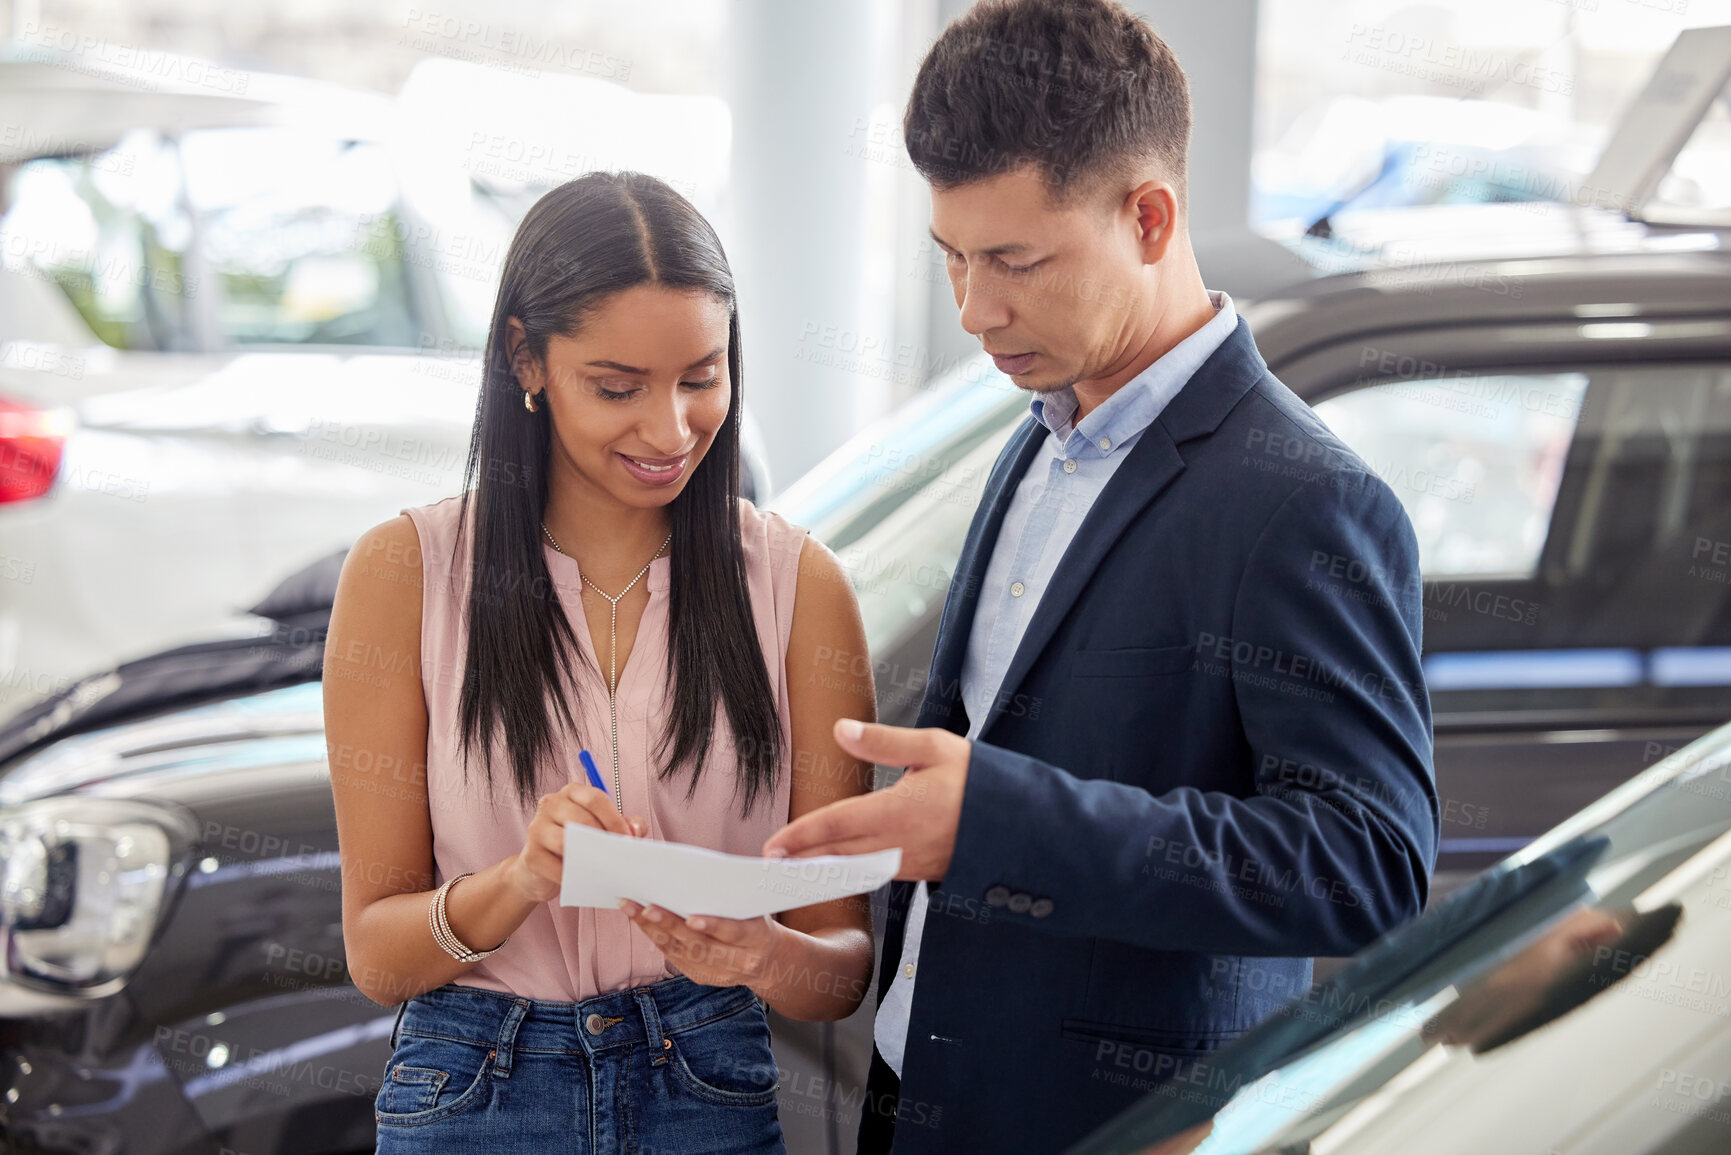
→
(724, 0, 885, 490)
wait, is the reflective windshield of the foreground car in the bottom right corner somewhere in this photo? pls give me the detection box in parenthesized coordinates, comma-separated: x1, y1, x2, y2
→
(1073, 726, 1731, 1155)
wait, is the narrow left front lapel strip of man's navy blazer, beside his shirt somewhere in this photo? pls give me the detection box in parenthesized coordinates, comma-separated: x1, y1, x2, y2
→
(914, 416, 1049, 734)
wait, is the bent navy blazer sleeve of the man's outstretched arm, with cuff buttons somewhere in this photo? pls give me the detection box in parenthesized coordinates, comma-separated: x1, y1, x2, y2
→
(933, 471, 1440, 956)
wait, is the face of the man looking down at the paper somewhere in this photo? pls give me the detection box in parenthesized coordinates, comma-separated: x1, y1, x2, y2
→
(931, 166, 1146, 393)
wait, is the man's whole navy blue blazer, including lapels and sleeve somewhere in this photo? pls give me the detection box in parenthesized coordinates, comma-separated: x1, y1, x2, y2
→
(860, 319, 1440, 1155)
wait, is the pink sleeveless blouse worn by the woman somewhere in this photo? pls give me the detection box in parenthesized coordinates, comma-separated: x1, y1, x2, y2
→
(402, 497, 805, 1003)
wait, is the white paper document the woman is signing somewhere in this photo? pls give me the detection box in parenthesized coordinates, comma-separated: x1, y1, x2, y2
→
(559, 823, 902, 918)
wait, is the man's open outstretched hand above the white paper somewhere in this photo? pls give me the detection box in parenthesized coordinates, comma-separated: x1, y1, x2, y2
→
(763, 719, 973, 881)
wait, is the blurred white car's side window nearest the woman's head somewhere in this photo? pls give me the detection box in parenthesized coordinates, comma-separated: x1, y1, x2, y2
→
(180, 128, 417, 346)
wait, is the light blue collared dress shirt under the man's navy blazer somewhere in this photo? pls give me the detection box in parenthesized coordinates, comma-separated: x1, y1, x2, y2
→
(872, 293, 1238, 1077)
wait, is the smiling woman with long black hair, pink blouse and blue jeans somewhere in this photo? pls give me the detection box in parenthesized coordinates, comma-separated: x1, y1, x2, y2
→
(324, 173, 874, 1155)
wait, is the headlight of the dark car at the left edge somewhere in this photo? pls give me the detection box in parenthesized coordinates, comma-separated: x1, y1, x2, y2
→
(0, 795, 197, 997)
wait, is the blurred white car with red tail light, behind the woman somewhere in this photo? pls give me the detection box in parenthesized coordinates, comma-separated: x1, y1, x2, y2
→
(0, 52, 770, 717)
